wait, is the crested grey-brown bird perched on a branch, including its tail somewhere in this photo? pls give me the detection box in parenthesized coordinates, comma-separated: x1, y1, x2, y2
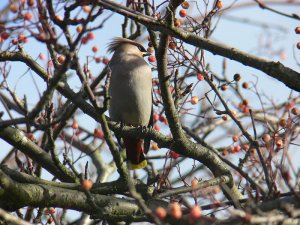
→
(107, 38, 153, 170)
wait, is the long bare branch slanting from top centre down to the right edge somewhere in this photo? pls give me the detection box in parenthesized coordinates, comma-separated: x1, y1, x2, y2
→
(98, 0, 300, 91)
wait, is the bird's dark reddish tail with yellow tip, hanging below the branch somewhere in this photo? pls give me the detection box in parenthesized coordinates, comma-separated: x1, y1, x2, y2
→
(124, 138, 147, 170)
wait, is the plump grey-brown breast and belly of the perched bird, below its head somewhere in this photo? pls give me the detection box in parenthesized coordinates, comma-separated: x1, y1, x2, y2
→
(109, 62, 152, 126)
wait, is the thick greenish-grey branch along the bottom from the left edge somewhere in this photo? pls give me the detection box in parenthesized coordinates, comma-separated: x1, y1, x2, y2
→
(0, 170, 168, 221)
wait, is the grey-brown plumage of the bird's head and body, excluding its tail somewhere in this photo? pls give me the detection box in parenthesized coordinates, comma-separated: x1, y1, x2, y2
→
(109, 38, 152, 126)
